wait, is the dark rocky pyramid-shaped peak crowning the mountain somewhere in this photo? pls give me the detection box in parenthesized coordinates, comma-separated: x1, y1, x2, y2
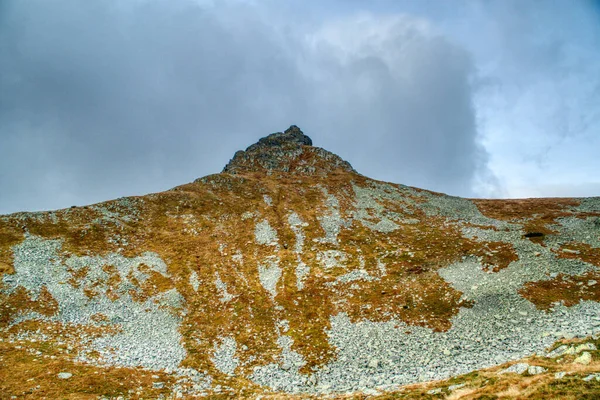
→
(223, 125, 356, 176)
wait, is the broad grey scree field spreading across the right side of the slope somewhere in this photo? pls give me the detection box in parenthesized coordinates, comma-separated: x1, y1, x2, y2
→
(240, 184, 600, 393)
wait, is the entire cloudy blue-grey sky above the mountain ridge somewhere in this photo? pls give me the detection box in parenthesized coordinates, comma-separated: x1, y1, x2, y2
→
(0, 0, 600, 214)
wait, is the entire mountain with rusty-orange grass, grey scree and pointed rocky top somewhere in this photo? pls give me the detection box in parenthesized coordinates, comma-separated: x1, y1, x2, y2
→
(0, 126, 600, 399)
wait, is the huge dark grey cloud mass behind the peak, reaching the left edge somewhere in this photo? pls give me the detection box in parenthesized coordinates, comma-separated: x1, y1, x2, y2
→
(0, 0, 489, 213)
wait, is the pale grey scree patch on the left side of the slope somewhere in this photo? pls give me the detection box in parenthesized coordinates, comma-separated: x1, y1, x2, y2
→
(4, 236, 186, 370)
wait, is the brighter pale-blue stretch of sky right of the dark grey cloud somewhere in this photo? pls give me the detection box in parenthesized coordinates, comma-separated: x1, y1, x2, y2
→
(467, 0, 600, 197)
